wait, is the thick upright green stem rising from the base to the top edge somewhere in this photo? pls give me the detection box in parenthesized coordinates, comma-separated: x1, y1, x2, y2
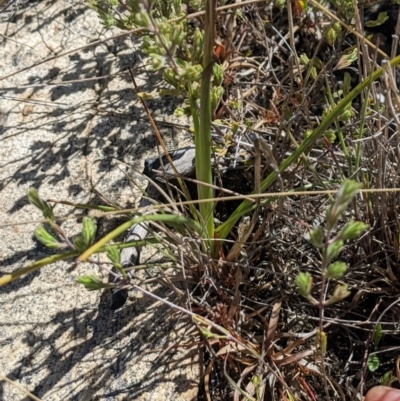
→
(195, 0, 216, 254)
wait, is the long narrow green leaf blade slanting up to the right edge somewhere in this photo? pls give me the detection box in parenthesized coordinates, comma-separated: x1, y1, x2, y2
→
(216, 56, 400, 239)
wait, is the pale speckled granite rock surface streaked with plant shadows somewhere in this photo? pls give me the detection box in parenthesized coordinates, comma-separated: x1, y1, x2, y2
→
(0, 0, 200, 401)
